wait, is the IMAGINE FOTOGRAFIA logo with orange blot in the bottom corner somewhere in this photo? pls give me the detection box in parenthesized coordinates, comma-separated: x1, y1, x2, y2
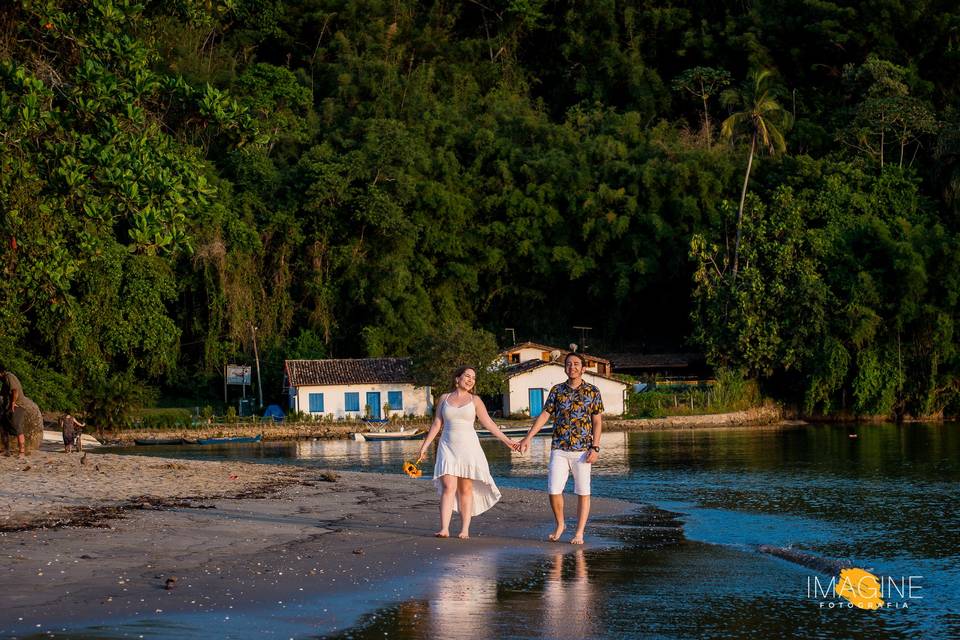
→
(807, 568, 923, 609)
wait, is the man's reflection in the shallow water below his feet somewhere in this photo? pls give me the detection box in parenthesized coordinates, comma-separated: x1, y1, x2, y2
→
(542, 549, 598, 638)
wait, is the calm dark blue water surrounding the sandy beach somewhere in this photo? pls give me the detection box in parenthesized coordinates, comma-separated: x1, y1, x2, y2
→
(95, 424, 960, 639)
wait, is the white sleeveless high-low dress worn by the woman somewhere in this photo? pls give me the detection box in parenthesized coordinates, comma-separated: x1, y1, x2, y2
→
(433, 401, 500, 515)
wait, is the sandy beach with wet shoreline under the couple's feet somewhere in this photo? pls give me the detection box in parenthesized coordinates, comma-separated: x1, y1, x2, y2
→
(0, 451, 680, 637)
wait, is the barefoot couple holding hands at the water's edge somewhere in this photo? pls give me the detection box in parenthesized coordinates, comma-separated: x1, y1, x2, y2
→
(417, 353, 603, 544)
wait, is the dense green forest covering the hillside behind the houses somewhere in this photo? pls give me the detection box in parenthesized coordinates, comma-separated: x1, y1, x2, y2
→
(0, 0, 960, 417)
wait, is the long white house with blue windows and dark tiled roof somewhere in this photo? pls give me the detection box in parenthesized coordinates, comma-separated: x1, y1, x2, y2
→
(283, 358, 433, 420)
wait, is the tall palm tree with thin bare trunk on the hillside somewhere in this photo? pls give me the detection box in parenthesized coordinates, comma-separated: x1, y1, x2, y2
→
(720, 69, 792, 282)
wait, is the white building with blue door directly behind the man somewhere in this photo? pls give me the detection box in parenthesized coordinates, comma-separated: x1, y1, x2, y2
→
(503, 358, 629, 418)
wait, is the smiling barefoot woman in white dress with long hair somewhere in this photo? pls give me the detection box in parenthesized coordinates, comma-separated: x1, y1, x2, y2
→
(417, 367, 520, 539)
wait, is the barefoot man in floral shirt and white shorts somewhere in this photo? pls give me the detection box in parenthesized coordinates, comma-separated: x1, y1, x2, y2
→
(520, 353, 603, 544)
